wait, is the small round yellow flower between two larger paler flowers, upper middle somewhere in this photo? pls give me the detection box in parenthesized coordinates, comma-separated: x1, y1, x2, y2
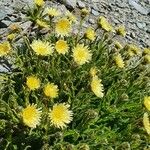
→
(55, 40, 69, 54)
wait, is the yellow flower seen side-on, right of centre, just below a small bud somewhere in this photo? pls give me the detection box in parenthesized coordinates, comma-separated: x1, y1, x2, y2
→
(91, 75, 104, 98)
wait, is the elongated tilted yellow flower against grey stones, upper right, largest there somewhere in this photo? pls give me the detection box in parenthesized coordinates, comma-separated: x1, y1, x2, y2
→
(98, 16, 113, 32)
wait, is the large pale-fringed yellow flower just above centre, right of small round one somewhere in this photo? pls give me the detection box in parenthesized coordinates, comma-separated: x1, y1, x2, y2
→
(73, 44, 92, 65)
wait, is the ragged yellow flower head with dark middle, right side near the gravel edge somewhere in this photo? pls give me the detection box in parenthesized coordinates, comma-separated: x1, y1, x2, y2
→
(126, 44, 141, 56)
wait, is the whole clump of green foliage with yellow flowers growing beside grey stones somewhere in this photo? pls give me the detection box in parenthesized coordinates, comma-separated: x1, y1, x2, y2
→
(0, 0, 150, 150)
